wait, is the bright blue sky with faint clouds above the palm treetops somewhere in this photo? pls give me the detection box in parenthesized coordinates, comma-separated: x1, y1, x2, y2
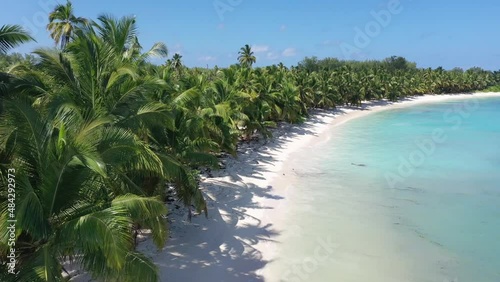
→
(0, 0, 500, 70)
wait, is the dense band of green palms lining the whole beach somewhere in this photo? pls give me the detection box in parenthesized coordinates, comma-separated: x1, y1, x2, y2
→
(0, 2, 500, 282)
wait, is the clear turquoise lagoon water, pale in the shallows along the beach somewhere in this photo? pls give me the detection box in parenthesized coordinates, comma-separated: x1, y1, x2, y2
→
(270, 98, 500, 282)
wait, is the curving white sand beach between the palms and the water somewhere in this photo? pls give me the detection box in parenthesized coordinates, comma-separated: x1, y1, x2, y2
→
(69, 93, 500, 282)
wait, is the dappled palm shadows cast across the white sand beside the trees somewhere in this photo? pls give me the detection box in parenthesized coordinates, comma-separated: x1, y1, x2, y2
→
(145, 107, 343, 282)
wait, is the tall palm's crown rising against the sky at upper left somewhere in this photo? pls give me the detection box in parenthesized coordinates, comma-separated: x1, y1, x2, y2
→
(47, 0, 88, 49)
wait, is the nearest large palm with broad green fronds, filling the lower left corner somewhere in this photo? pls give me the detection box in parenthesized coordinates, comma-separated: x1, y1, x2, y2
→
(0, 95, 167, 282)
